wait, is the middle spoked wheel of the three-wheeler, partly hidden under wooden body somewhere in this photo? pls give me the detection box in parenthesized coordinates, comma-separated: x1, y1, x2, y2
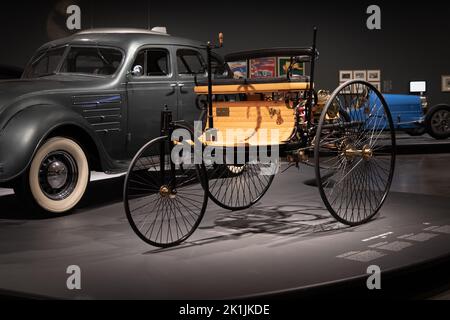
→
(207, 149, 276, 211)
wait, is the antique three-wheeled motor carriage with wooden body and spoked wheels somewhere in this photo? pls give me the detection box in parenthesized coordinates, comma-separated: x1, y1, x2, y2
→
(124, 30, 395, 247)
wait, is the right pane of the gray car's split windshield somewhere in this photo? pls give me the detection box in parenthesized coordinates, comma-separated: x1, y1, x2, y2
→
(60, 47, 122, 75)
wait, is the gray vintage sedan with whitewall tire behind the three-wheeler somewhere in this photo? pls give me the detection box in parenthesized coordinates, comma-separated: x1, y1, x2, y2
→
(0, 28, 231, 213)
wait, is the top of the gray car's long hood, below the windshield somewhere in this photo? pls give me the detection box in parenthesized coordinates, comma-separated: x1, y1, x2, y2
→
(0, 76, 110, 114)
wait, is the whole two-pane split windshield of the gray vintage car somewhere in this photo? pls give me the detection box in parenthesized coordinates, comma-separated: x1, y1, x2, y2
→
(24, 47, 123, 78)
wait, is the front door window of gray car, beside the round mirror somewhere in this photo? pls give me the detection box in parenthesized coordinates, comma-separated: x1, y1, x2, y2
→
(131, 49, 170, 77)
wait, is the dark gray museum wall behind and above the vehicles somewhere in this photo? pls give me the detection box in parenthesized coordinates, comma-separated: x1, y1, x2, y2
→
(0, 0, 450, 104)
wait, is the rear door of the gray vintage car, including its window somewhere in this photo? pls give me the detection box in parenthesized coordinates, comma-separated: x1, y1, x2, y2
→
(173, 46, 207, 125)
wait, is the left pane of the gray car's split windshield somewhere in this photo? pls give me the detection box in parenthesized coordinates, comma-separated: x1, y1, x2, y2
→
(25, 47, 66, 78)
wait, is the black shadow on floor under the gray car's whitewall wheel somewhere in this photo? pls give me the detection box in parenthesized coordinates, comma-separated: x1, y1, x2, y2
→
(0, 177, 124, 220)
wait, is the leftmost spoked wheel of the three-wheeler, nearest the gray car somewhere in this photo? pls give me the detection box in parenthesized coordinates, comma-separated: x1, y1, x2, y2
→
(124, 136, 208, 247)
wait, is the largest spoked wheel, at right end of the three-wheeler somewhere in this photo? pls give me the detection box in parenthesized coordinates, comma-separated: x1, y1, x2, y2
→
(314, 80, 395, 226)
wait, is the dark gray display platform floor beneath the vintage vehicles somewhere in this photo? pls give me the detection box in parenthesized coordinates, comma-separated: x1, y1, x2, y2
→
(0, 154, 450, 299)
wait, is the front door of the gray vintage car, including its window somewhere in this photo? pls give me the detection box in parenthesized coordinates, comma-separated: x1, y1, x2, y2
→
(127, 46, 178, 155)
